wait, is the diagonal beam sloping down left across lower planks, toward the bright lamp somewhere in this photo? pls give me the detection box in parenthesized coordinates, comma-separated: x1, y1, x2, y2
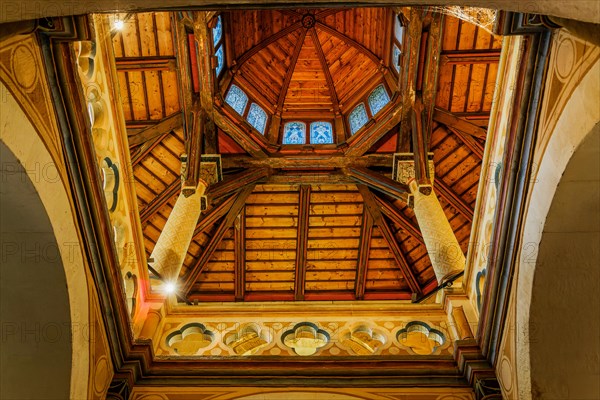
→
(181, 185, 254, 297)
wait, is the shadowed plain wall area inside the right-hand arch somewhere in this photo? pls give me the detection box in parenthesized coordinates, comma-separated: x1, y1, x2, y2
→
(529, 123, 600, 399)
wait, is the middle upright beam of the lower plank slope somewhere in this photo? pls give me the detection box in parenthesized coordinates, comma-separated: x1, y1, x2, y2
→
(294, 185, 310, 300)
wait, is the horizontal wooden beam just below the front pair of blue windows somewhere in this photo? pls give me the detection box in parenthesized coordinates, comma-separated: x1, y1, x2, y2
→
(221, 152, 394, 169)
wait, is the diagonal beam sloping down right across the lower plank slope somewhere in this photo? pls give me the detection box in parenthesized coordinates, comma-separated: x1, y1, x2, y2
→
(357, 185, 422, 295)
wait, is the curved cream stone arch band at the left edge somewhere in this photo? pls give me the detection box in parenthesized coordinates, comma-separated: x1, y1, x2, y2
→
(0, 83, 90, 399)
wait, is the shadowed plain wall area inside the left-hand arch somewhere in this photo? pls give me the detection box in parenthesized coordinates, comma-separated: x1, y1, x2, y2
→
(0, 142, 72, 399)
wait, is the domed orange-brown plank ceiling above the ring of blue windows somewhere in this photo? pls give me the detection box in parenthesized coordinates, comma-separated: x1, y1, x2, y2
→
(223, 8, 393, 119)
